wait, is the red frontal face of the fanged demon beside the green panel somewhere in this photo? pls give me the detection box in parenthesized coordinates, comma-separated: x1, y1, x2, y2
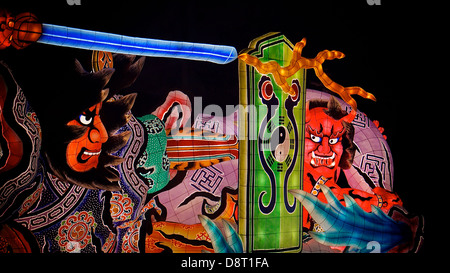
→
(304, 104, 345, 178)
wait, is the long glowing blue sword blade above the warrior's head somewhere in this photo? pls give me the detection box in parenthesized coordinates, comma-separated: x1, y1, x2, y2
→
(38, 24, 237, 64)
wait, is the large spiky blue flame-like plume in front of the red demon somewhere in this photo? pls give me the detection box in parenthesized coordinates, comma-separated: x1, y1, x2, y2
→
(289, 185, 411, 252)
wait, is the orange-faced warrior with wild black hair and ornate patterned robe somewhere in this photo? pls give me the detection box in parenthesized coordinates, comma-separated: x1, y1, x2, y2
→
(0, 39, 151, 252)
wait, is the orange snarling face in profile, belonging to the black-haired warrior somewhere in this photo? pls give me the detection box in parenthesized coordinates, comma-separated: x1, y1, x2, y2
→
(66, 102, 108, 172)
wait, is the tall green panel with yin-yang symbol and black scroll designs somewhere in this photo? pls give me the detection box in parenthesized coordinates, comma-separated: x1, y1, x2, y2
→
(239, 33, 306, 252)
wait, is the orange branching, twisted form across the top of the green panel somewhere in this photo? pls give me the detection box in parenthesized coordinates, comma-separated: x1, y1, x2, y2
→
(238, 38, 376, 111)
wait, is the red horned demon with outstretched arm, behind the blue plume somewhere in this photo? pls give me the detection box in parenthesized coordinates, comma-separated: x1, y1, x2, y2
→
(303, 97, 402, 219)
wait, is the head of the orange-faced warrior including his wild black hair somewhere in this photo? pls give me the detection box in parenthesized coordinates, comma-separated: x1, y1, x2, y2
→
(4, 50, 136, 190)
